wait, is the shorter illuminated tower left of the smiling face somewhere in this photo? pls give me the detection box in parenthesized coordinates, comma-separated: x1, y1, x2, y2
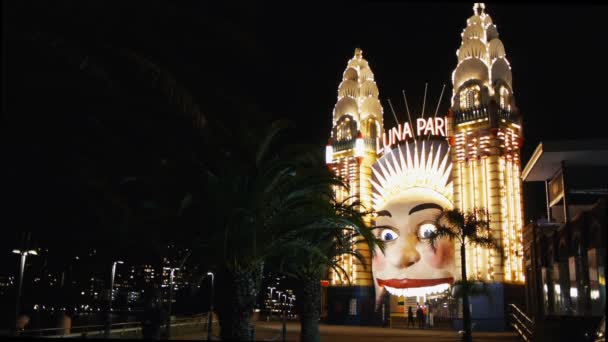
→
(326, 49, 383, 288)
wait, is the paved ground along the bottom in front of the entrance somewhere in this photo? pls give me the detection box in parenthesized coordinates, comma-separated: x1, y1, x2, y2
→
(173, 322, 519, 342)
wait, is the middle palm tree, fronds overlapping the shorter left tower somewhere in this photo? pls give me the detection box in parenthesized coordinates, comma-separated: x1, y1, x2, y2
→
(280, 194, 382, 342)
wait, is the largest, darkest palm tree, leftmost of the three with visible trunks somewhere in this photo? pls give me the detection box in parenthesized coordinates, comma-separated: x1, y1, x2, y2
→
(194, 121, 352, 340)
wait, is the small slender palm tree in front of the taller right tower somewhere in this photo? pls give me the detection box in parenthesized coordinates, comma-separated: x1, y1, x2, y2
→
(427, 209, 502, 342)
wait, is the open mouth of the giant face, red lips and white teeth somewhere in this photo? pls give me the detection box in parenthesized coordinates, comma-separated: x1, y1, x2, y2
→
(376, 277, 454, 297)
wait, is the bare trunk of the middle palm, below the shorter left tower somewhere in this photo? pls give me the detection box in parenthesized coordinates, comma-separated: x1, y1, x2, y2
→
(297, 274, 321, 342)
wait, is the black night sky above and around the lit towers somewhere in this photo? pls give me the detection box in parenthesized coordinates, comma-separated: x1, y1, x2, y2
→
(0, 1, 608, 272)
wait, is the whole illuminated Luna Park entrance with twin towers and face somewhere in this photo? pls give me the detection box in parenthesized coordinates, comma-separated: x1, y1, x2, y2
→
(326, 4, 524, 324)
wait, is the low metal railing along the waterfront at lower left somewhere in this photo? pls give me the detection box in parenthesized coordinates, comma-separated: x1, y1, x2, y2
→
(12, 314, 218, 338)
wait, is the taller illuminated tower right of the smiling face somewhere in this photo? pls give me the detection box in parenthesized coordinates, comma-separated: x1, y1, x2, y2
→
(448, 3, 524, 283)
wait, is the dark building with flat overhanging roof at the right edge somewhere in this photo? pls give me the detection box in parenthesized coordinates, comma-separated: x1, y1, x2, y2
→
(523, 139, 608, 322)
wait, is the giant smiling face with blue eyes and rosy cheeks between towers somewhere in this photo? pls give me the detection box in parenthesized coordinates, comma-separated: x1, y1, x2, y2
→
(372, 187, 454, 306)
